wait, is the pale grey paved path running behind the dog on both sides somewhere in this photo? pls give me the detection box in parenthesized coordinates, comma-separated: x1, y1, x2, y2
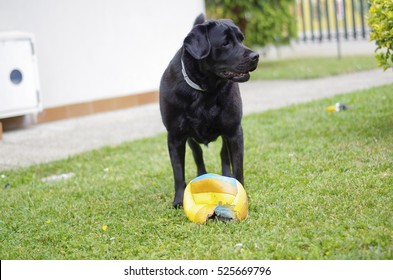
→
(0, 69, 393, 171)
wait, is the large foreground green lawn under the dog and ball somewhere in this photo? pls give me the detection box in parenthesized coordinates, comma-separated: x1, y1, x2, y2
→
(0, 85, 393, 259)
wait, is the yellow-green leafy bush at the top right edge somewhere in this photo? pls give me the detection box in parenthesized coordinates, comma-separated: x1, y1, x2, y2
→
(368, 0, 393, 70)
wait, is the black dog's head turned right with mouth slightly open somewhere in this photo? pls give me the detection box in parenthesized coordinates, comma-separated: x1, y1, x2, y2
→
(184, 20, 259, 82)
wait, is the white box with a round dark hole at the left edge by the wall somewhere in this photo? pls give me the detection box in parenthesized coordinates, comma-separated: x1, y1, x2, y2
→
(0, 31, 42, 119)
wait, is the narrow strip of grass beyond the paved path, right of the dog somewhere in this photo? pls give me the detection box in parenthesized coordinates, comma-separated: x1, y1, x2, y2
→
(251, 55, 377, 80)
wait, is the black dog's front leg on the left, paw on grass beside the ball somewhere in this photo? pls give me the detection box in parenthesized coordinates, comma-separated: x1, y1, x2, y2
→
(168, 133, 186, 208)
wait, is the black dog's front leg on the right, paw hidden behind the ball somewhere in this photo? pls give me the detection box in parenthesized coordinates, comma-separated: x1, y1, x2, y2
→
(225, 126, 244, 186)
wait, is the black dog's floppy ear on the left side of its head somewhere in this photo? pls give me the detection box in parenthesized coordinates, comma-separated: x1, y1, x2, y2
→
(183, 24, 211, 60)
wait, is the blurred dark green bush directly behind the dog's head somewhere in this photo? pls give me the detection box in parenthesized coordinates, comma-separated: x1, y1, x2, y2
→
(206, 0, 296, 46)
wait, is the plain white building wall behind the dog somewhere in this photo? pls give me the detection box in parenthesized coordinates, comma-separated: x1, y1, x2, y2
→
(0, 0, 204, 108)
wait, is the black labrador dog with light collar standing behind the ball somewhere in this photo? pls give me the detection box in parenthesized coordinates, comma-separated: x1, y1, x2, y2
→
(160, 14, 259, 208)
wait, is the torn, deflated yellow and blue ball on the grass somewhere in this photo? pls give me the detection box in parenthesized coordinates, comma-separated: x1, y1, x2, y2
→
(183, 173, 248, 223)
